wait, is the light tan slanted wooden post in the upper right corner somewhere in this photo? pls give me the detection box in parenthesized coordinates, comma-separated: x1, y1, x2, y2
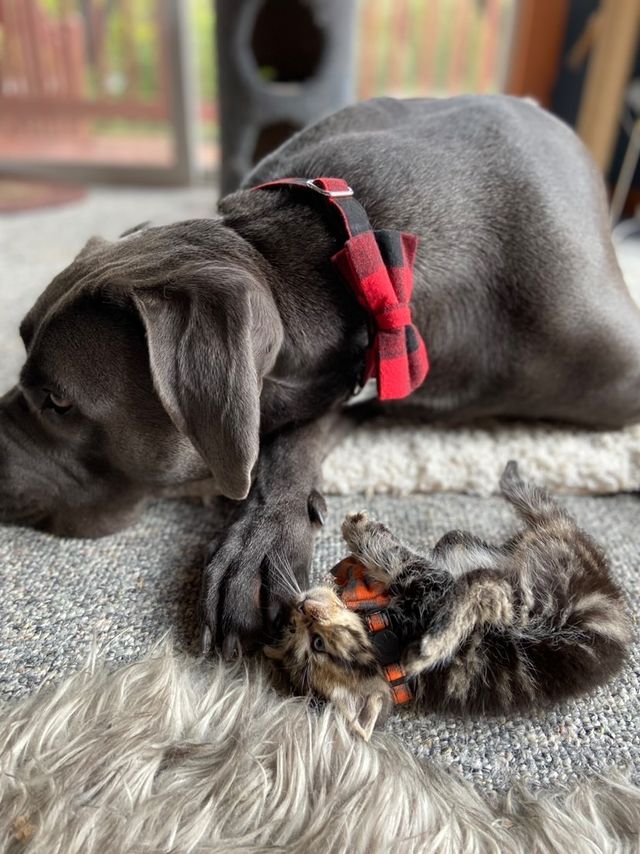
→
(577, 0, 640, 172)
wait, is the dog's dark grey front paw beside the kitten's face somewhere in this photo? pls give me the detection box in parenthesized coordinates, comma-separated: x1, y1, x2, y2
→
(200, 490, 326, 659)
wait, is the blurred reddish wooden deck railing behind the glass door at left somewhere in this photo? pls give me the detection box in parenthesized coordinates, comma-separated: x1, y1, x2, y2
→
(0, 0, 169, 123)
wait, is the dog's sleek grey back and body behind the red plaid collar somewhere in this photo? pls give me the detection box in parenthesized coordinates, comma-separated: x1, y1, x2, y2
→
(242, 95, 640, 426)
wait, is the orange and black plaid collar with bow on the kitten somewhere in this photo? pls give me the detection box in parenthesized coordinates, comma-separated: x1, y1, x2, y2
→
(331, 557, 413, 706)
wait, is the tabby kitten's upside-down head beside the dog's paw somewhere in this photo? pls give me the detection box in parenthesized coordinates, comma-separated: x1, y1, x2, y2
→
(265, 587, 392, 741)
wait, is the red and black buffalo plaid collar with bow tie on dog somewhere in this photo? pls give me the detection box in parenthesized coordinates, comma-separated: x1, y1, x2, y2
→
(254, 178, 429, 400)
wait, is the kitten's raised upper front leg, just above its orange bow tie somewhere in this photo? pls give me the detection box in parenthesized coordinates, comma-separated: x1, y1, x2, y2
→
(342, 511, 429, 584)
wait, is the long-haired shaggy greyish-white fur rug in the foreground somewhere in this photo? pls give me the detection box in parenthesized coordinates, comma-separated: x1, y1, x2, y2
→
(0, 644, 640, 854)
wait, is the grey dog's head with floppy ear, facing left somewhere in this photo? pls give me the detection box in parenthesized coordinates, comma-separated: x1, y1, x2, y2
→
(0, 220, 283, 536)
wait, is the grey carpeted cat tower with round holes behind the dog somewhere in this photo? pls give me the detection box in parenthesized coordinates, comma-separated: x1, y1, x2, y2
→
(216, 0, 357, 195)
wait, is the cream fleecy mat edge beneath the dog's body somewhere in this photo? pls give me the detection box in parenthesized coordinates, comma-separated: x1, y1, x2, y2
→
(324, 422, 640, 495)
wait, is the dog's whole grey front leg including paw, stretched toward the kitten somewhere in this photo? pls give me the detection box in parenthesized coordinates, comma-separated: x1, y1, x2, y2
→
(200, 412, 352, 658)
